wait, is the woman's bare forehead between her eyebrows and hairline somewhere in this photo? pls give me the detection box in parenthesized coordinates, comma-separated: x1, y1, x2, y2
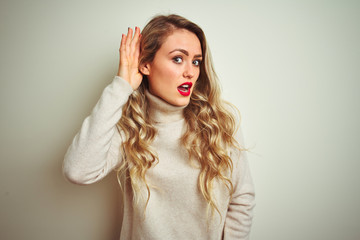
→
(159, 29, 202, 55)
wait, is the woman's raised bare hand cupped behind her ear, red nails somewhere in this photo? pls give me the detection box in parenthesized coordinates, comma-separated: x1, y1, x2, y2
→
(118, 27, 143, 90)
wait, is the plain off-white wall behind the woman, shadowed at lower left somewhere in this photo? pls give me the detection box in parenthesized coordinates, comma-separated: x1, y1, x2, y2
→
(0, 0, 360, 240)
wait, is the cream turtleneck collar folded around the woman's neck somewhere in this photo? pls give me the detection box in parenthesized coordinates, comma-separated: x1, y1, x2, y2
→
(145, 90, 186, 123)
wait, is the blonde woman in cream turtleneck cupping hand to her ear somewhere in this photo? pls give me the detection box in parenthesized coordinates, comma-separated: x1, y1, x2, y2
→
(63, 15, 254, 240)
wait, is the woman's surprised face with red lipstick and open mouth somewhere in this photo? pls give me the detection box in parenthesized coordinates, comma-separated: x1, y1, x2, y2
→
(141, 29, 202, 106)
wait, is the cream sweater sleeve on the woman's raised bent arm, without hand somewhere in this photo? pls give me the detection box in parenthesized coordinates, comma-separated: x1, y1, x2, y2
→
(63, 76, 133, 184)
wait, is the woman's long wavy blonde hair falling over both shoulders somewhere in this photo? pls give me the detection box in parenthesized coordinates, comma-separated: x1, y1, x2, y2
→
(118, 14, 238, 218)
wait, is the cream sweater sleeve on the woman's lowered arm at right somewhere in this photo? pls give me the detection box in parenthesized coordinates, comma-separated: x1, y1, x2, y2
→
(224, 124, 255, 240)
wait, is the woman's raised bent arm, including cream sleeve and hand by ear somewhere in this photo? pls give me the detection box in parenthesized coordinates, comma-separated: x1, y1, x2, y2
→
(63, 27, 142, 184)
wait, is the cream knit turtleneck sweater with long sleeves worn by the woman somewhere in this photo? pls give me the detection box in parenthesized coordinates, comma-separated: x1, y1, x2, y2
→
(63, 76, 255, 240)
